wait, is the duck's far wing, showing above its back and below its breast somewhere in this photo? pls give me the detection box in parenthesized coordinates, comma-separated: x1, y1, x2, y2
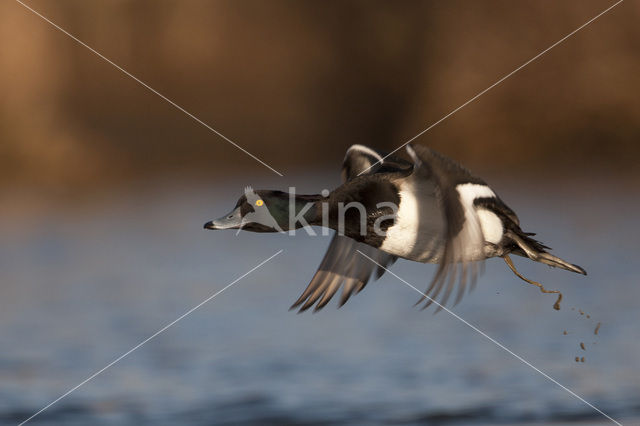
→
(291, 145, 413, 312)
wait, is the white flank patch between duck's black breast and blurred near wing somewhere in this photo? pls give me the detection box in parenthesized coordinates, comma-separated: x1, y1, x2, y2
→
(380, 182, 420, 257)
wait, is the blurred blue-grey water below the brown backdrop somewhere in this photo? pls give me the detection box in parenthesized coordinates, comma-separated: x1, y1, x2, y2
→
(0, 176, 640, 425)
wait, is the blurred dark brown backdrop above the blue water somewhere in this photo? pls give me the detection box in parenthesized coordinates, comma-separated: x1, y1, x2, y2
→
(0, 0, 640, 190)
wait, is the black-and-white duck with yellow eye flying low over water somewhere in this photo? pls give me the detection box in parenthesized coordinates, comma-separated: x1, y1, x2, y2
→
(204, 144, 587, 312)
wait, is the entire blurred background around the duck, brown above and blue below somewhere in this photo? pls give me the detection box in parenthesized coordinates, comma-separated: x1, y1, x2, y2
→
(0, 0, 640, 424)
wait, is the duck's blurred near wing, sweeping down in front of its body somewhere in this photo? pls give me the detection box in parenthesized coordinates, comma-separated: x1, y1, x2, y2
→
(407, 145, 488, 312)
